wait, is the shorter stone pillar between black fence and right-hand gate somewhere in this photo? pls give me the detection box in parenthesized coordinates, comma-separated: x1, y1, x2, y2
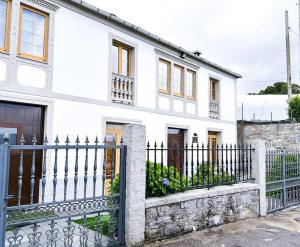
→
(249, 140, 267, 216)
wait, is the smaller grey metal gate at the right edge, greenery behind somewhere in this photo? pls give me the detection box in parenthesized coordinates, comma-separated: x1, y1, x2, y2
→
(266, 150, 300, 212)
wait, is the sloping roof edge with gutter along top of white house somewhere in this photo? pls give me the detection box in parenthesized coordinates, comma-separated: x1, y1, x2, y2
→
(64, 0, 242, 78)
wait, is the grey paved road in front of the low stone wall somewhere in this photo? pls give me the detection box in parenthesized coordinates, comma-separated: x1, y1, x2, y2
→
(147, 208, 300, 247)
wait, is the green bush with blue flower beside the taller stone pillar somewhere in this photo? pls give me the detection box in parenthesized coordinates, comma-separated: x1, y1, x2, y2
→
(146, 162, 186, 197)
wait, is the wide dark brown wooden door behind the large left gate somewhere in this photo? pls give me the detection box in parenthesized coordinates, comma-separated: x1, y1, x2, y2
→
(0, 101, 44, 205)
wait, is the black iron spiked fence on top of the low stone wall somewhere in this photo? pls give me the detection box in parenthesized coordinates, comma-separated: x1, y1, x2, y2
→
(146, 142, 254, 197)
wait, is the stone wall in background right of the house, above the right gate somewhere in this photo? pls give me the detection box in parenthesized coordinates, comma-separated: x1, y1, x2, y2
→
(237, 121, 300, 149)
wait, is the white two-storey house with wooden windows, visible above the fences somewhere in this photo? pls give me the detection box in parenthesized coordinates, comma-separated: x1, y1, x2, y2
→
(0, 0, 241, 199)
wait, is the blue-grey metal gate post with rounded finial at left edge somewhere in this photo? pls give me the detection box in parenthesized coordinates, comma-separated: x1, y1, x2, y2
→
(0, 133, 9, 246)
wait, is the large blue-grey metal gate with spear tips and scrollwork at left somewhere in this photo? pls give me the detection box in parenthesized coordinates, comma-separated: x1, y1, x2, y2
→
(0, 135, 127, 247)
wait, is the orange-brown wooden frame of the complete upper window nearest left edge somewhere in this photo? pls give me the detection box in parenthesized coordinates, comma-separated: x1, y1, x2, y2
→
(17, 3, 49, 63)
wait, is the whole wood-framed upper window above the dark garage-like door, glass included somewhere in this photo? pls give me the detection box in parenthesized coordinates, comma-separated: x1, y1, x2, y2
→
(18, 5, 49, 62)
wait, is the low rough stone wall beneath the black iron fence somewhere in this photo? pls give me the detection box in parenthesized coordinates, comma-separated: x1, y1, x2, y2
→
(145, 183, 259, 241)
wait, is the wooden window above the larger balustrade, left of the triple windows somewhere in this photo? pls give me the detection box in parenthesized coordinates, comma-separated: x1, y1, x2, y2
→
(113, 43, 131, 76)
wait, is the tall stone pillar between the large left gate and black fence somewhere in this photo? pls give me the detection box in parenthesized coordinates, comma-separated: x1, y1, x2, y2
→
(123, 124, 146, 246)
